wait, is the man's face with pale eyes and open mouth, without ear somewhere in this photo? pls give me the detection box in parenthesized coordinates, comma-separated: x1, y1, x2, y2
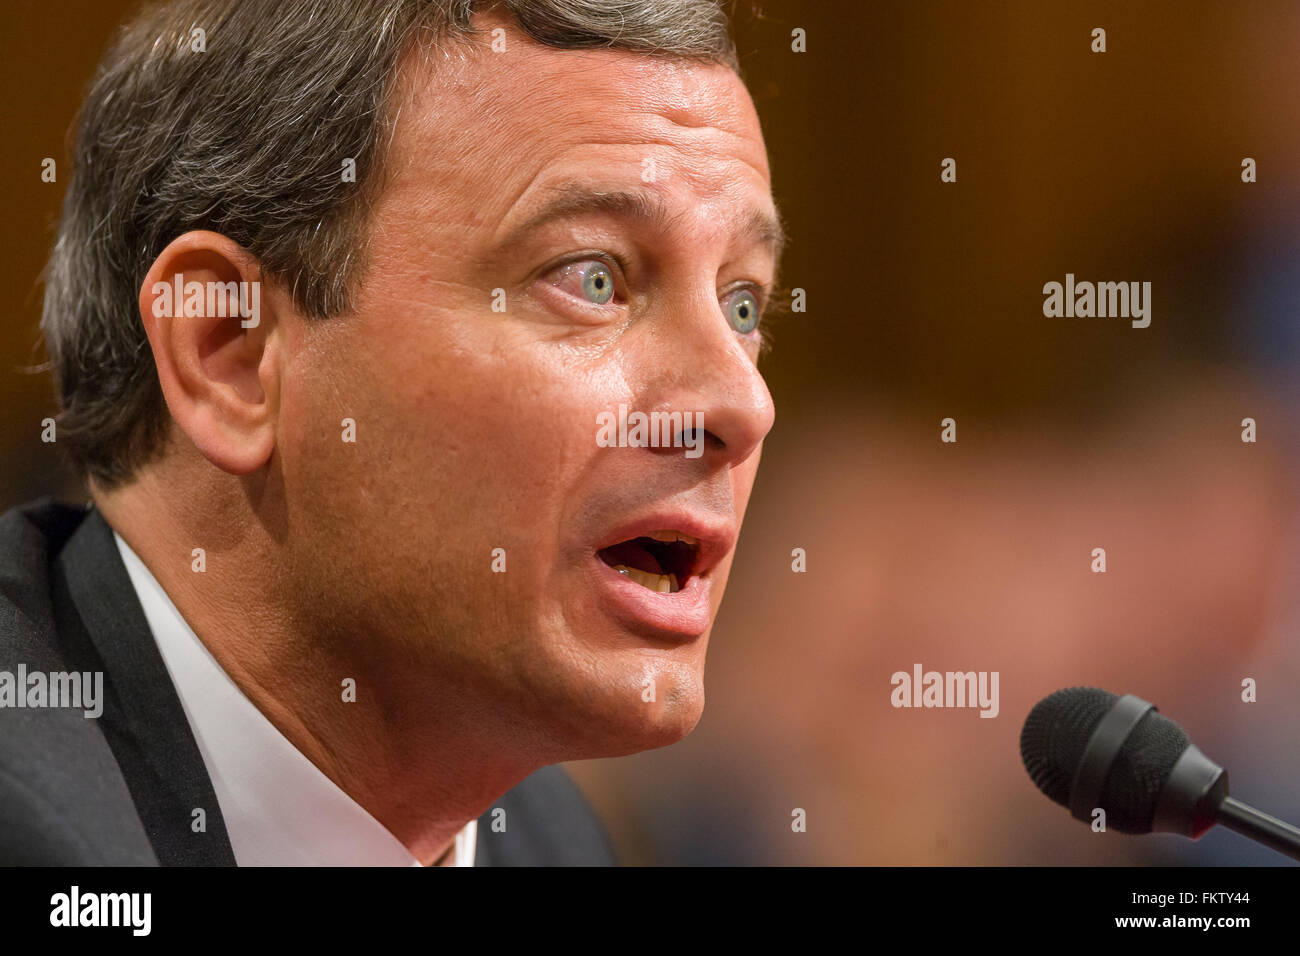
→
(278, 18, 776, 762)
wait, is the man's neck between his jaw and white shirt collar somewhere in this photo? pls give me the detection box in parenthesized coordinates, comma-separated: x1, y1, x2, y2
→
(94, 467, 536, 866)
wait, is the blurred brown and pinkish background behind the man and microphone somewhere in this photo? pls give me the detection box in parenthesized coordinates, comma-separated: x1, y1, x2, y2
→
(0, 0, 1300, 865)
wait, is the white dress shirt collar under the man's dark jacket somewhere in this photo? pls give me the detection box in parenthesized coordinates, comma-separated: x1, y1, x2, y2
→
(113, 531, 478, 866)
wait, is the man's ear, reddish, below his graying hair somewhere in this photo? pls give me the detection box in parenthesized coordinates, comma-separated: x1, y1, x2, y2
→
(140, 232, 280, 475)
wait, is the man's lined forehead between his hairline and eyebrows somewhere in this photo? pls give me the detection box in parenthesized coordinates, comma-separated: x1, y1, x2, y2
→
(389, 17, 771, 230)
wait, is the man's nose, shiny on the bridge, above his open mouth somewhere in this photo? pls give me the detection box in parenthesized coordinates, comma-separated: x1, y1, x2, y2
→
(639, 290, 776, 467)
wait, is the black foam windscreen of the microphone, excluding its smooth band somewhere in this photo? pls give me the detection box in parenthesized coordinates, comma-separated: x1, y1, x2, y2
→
(1021, 687, 1191, 834)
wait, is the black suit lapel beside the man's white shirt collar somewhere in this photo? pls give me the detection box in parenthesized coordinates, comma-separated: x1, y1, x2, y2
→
(55, 509, 235, 866)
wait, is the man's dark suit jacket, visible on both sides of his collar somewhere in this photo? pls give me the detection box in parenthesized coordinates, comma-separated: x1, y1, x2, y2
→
(0, 498, 614, 866)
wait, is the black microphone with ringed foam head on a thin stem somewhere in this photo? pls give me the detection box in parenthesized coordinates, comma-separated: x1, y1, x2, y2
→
(1021, 687, 1300, 860)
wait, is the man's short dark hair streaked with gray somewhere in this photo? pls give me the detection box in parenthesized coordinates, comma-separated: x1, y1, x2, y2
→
(40, 0, 740, 488)
